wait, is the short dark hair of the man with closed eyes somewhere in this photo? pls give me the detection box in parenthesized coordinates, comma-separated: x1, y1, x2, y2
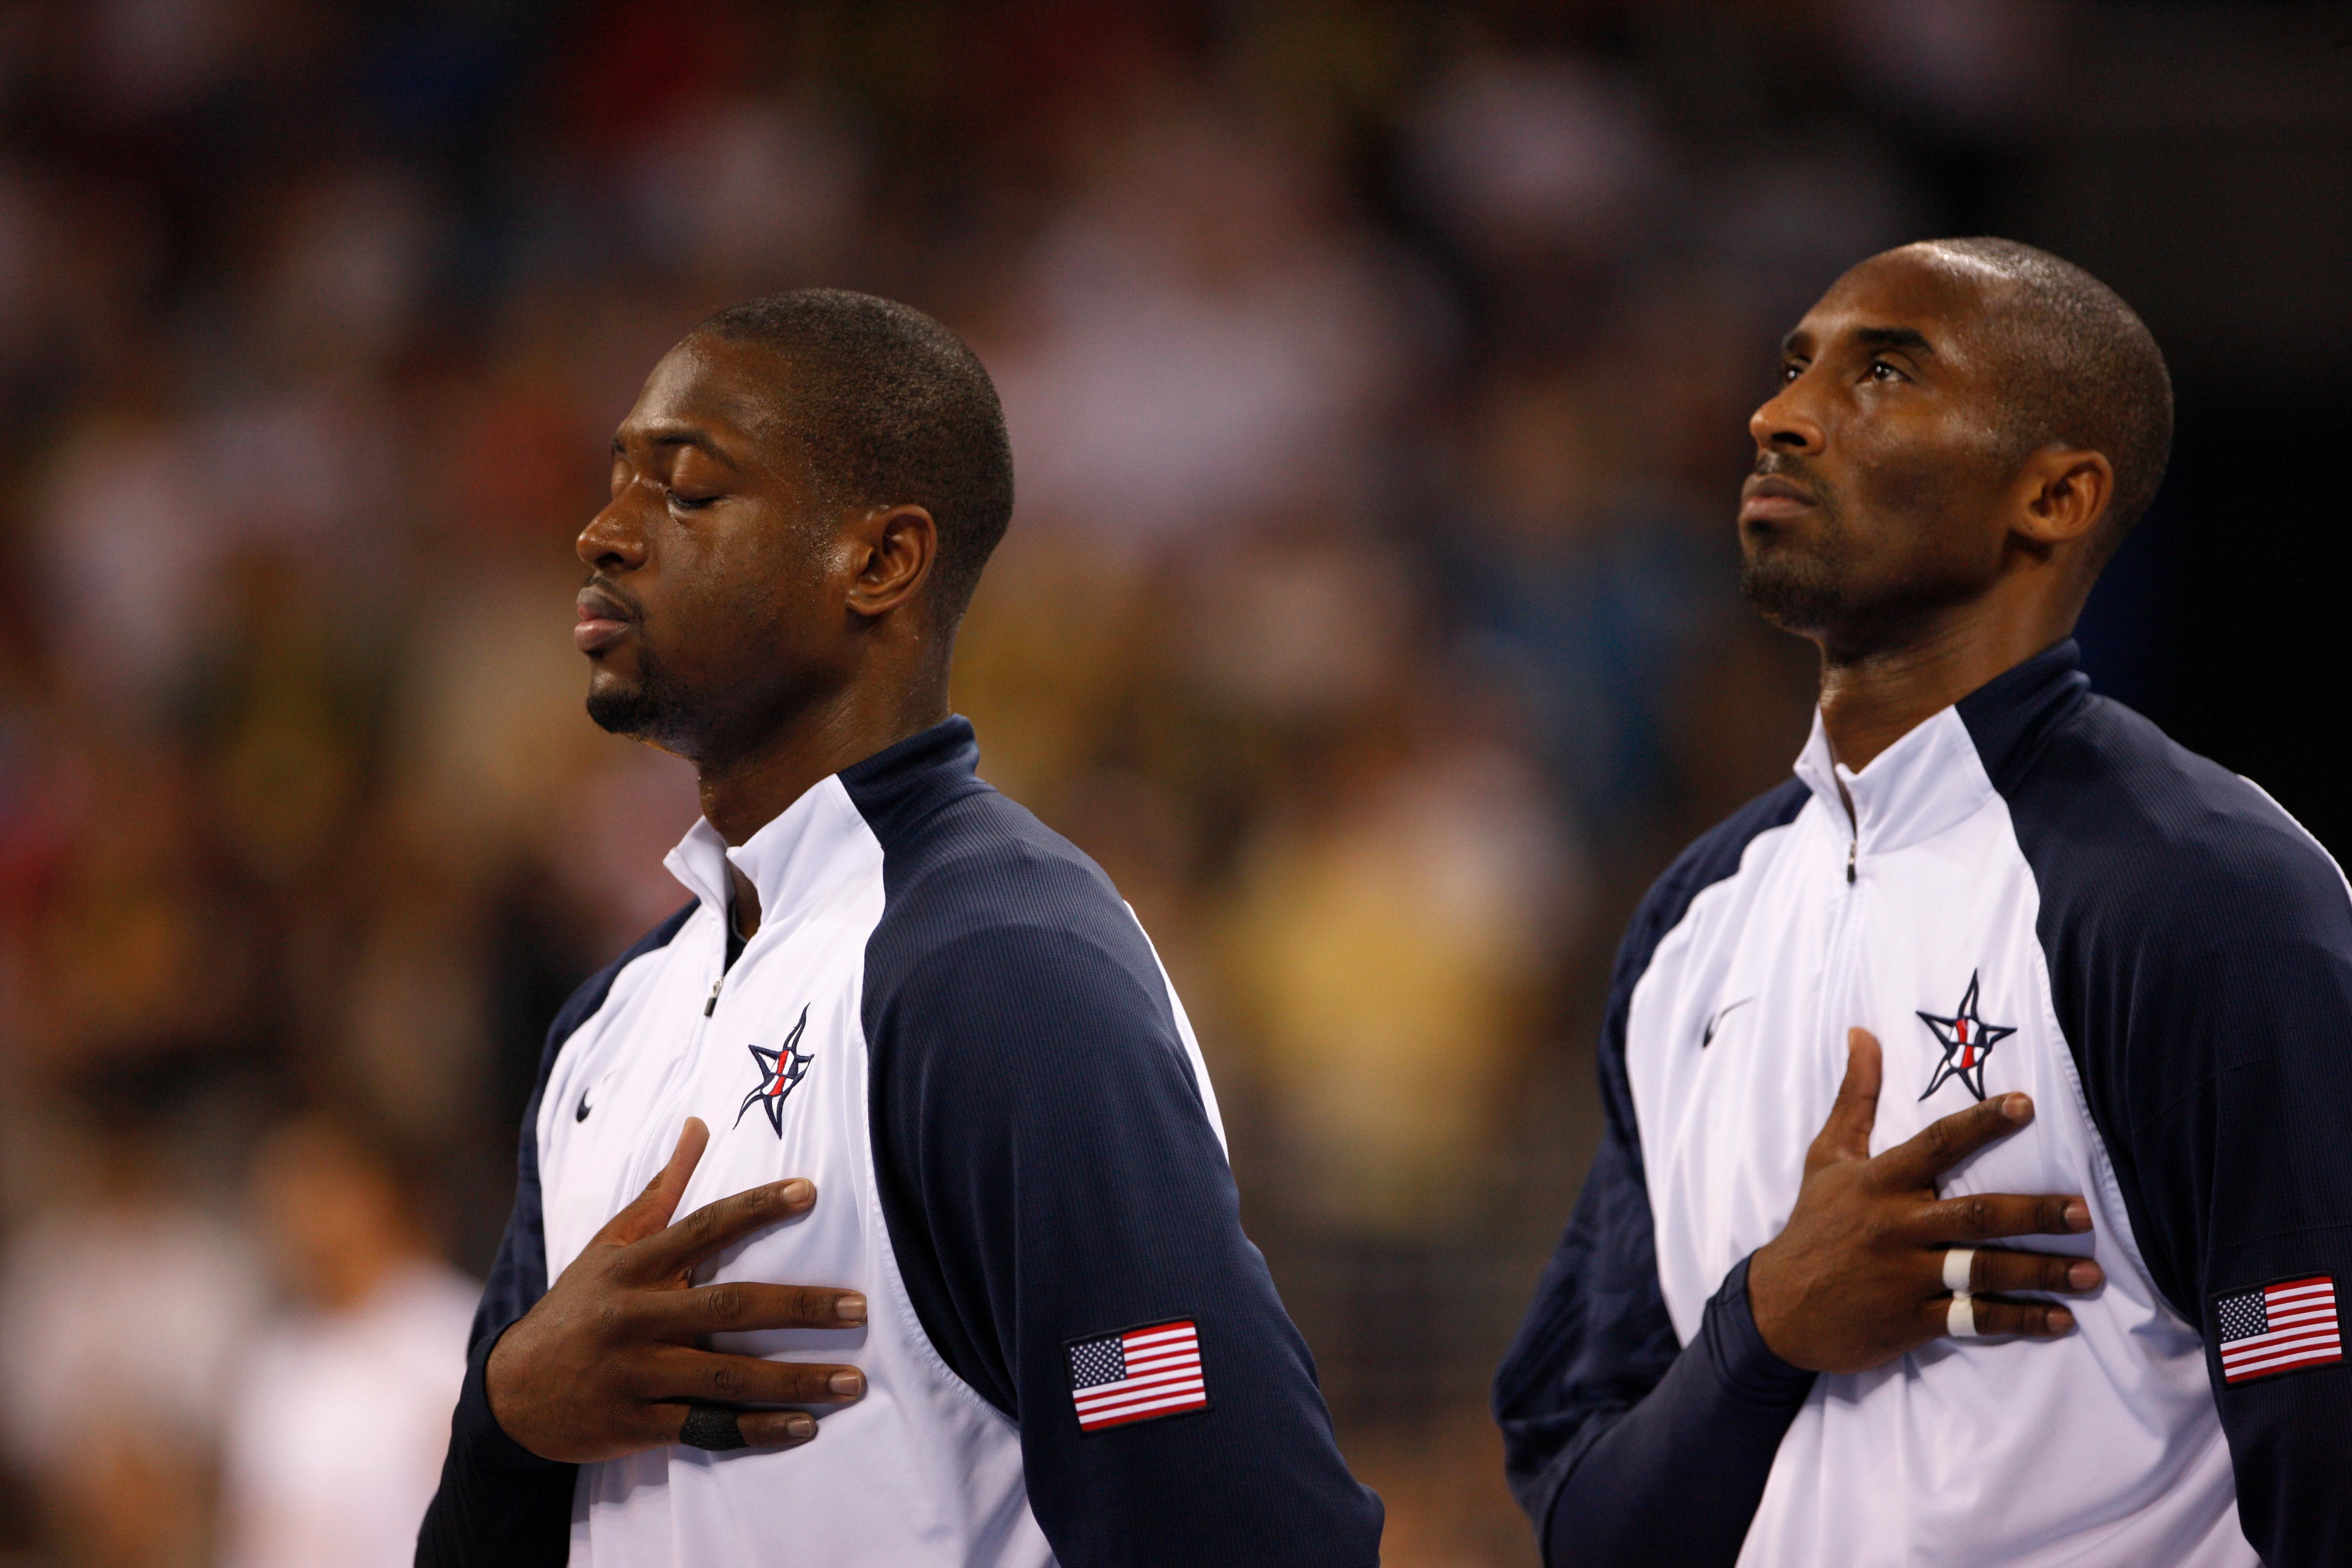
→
(694, 289, 1014, 625)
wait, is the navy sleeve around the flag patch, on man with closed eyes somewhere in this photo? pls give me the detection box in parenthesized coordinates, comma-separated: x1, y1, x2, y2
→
(868, 921, 1381, 1568)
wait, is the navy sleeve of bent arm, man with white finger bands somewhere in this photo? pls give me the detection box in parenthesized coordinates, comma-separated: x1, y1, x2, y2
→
(1493, 781, 1813, 1568)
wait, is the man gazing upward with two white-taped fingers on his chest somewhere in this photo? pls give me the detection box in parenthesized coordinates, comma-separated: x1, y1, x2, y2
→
(1496, 240, 2352, 1568)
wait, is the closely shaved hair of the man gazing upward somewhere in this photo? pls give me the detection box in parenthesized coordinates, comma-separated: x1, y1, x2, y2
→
(1924, 235, 2173, 560)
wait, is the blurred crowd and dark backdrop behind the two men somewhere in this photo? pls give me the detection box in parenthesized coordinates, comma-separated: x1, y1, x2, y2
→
(0, 0, 2352, 1568)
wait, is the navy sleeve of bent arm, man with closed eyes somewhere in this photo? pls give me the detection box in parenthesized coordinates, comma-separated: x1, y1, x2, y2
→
(416, 903, 694, 1568)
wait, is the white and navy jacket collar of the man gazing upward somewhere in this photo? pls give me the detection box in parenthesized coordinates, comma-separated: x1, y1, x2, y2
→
(1797, 642, 2091, 854)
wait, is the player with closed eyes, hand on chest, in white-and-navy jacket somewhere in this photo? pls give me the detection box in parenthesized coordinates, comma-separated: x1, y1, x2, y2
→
(419, 291, 1381, 1568)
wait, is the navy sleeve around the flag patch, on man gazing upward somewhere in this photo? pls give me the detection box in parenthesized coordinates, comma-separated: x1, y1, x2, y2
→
(1962, 691, 2352, 1568)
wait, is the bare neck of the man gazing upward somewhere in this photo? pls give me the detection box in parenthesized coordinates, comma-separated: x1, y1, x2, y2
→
(1813, 604, 2074, 771)
